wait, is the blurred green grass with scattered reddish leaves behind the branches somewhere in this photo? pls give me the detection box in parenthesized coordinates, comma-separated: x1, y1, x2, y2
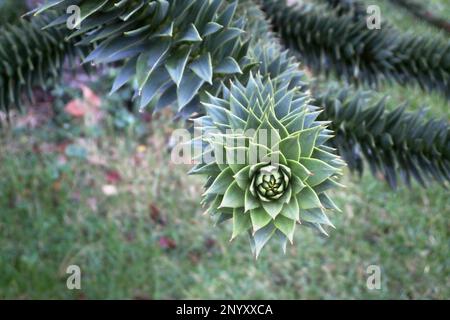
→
(0, 0, 450, 299)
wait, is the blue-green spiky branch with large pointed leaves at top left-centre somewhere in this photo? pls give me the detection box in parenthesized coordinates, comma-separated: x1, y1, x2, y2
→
(35, 0, 252, 115)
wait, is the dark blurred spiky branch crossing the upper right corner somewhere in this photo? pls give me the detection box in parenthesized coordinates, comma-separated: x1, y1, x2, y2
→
(261, 0, 450, 96)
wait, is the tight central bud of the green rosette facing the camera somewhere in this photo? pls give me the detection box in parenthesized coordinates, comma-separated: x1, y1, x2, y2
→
(252, 165, 289, 202)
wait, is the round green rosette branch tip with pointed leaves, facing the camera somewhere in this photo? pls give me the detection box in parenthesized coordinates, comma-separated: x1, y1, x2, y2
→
(191, 74, 345, 257)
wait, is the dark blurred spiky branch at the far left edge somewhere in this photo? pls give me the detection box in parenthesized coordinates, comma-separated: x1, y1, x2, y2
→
(0, 15, 83, 112)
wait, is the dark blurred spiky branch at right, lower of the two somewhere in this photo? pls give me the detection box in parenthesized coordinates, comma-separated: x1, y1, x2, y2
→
(316, 88, 450, 188)
